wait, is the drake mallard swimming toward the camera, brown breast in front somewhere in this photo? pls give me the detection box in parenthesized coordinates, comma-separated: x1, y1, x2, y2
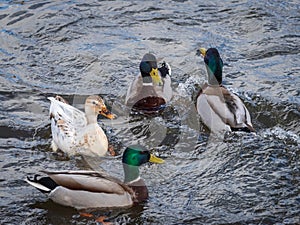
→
(125, 53, 172, 113)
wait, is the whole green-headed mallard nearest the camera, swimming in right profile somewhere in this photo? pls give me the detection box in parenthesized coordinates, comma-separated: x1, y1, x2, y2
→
(25, 145, 164, 209)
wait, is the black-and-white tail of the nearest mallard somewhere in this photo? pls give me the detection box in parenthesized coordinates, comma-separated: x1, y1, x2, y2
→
(25, 175, 58, 193)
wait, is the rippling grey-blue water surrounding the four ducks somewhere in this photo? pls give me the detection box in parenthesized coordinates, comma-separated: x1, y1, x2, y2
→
(0, 0, 300, 224)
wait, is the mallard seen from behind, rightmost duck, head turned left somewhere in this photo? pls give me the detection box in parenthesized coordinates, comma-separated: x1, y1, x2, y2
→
(196, 48, 254, 132)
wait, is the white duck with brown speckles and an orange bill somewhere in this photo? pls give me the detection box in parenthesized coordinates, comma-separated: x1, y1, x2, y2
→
(48, 95, 114, 156)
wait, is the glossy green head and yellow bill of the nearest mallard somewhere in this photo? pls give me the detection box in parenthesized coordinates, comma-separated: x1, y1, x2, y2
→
(122, 145, 164, 166)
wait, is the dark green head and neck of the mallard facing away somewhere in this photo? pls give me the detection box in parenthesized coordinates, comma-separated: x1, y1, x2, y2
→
(200, 48, 223, 85)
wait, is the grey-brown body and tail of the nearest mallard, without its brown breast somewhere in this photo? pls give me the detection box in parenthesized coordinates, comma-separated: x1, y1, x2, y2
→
(27, 171, 134, 209)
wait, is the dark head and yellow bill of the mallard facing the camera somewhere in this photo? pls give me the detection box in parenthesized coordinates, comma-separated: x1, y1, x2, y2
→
(140, 53, 162, 85)
